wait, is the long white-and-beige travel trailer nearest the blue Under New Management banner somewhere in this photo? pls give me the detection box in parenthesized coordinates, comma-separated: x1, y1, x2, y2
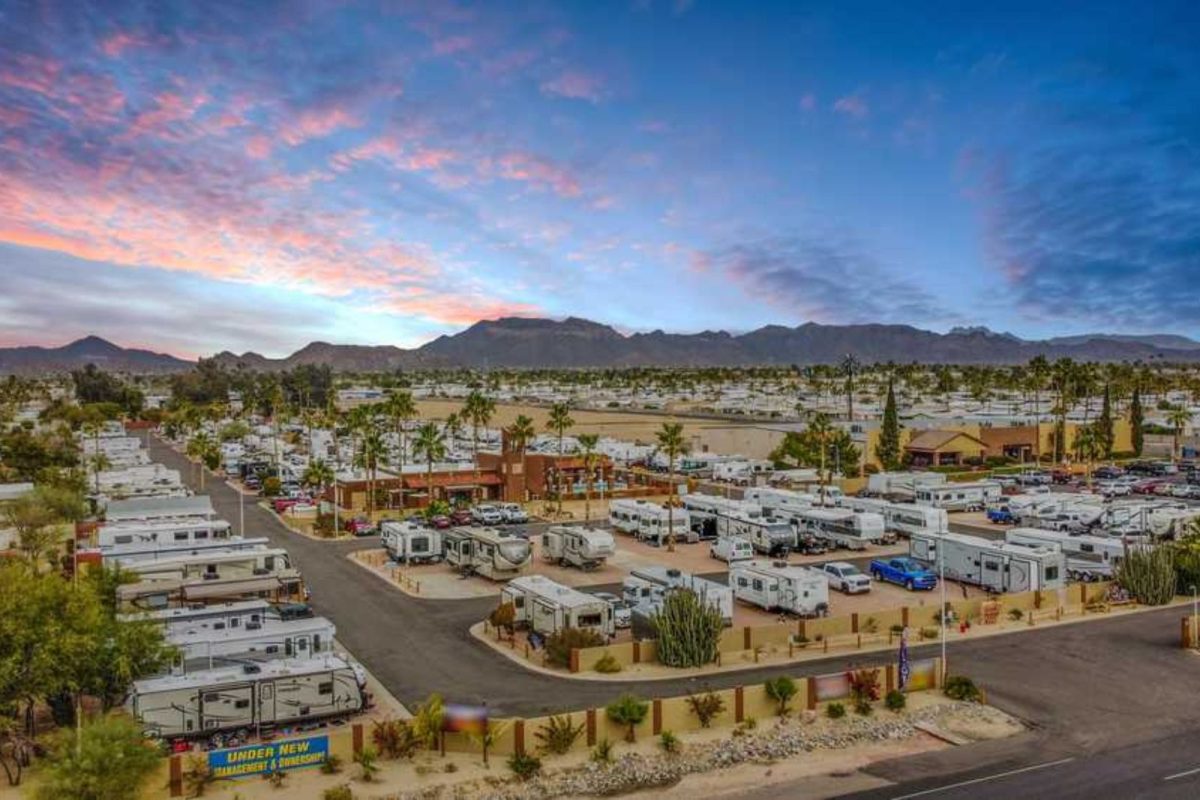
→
(126, 655, 367, 739)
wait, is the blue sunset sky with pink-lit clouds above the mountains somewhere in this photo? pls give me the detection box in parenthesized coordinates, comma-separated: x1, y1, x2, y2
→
(0, 0, 1200, 356)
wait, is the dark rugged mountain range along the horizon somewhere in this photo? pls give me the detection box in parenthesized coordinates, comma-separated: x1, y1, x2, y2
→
(0, 317, 1200, 374)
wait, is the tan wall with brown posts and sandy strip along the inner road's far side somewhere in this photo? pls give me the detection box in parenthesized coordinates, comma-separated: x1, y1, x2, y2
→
(472, 582, 1187, 681)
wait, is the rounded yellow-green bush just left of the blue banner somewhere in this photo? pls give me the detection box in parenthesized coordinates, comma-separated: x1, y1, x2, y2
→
(35, 714, 162, 800)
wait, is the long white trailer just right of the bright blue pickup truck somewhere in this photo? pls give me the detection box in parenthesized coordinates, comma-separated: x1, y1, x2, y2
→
(908, 534, 1067, 593)
